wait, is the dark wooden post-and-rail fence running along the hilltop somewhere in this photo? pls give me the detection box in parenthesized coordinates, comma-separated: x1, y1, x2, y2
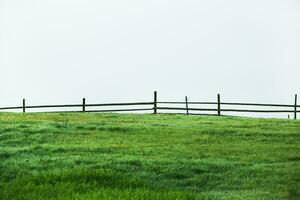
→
(0, 91, 300, 119)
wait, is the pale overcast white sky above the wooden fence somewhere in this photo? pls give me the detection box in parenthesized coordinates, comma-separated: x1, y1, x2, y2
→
(0, 0, 300, 117)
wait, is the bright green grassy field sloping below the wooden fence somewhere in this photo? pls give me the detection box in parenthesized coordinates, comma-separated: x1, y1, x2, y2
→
(0, 113, 300, 200)
